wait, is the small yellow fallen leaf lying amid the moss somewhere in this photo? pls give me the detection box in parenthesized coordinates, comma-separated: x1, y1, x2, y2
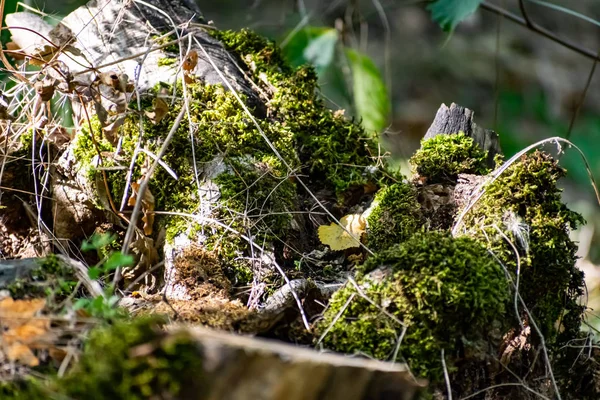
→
(319, 214, 367, 250)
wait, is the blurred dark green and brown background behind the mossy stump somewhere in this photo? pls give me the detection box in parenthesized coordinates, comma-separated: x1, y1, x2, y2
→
(2, 0, 600, 329)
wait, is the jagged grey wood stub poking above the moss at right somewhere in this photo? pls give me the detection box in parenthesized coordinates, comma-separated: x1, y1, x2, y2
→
(424, 103, 502, 168)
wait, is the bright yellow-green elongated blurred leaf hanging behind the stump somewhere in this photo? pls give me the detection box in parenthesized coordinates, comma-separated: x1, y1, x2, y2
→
(346, 49, 391, 132)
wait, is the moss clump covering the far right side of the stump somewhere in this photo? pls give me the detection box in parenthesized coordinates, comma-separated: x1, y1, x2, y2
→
(462, 152, 584, 344)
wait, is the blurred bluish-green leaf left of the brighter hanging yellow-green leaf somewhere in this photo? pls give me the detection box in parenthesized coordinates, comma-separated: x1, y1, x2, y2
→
(283, 26, 338, 76)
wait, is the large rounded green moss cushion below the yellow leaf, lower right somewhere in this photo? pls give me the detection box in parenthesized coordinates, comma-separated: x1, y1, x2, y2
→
(317, 232, 509, 382)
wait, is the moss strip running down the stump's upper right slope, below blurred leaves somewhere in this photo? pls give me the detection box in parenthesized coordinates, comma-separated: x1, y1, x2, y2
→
(211, 30, 385, 195)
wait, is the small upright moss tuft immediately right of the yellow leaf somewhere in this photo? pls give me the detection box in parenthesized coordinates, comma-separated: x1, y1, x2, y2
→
(367, 182, 422, 251)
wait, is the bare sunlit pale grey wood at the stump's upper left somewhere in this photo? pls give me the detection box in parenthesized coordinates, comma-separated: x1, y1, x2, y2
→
(60, 0, 256, 100)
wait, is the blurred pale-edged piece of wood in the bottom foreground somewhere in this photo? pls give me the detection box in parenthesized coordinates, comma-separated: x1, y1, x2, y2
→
(176, 328, 424, 400)
